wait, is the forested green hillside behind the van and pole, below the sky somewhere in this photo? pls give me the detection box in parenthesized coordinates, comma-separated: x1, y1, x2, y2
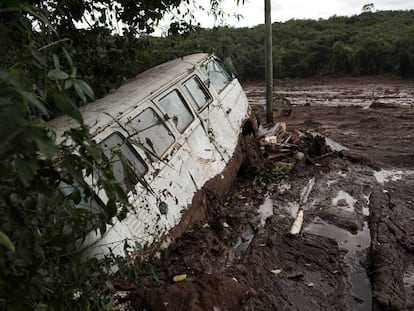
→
(64, 10, 414, 94)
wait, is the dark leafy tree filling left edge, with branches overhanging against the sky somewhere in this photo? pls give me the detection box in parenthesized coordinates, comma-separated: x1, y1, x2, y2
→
(0, 0, 233, 310)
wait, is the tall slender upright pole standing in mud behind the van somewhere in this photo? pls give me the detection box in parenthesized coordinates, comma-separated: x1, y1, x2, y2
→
(265, 0, 273, 123)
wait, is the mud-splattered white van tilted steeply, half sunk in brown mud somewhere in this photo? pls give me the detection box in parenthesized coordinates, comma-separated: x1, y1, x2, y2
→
(50, 54, 256, 257)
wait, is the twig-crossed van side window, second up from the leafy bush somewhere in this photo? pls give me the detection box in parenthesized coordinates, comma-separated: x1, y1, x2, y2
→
(127, 108, 175, 157)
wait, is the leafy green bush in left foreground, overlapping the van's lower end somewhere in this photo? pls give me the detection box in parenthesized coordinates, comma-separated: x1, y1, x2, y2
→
(0, 51, 127, 310)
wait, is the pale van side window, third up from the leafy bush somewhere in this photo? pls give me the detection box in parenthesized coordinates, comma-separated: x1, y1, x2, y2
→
(159, 90, 194, 133)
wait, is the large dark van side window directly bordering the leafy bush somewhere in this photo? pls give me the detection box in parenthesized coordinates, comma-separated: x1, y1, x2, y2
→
(100, 132, 147, 190)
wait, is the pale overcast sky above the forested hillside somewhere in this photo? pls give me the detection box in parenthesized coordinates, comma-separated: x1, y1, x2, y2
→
(156, 0, 414, 33)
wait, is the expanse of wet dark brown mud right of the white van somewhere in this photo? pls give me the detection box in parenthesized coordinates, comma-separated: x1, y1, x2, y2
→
(120, 78, 414, 310)
